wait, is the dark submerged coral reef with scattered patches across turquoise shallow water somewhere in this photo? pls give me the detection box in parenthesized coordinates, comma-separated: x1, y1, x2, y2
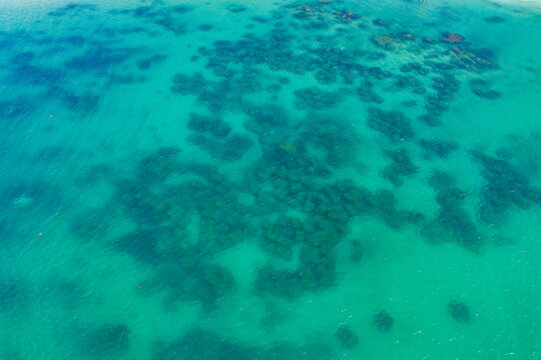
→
(12, 0, 524, 354)
